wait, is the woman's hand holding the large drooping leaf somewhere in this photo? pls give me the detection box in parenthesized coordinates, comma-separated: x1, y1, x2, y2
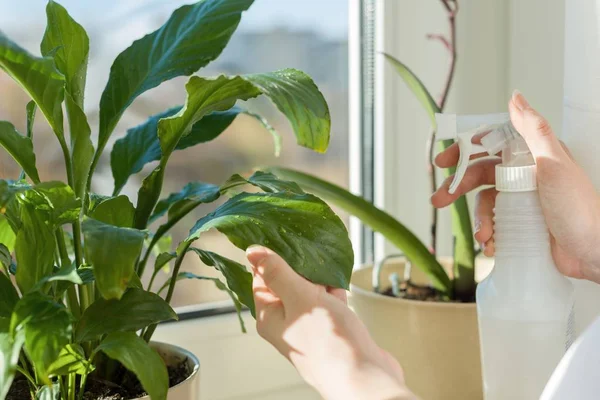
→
(246, 246, 414, 400)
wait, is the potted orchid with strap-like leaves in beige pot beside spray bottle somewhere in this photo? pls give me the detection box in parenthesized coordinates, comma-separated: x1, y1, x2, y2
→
(267, 0, 488, 400)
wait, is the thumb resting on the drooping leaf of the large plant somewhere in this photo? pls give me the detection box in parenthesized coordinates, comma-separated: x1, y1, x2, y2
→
(246, 246, 316, 307)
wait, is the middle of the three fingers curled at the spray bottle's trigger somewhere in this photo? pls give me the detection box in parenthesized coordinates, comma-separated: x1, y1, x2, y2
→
(431, 159, 502, 208)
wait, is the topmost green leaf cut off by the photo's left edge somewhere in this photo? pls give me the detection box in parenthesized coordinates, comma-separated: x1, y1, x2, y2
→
(0, 32, 65, 143)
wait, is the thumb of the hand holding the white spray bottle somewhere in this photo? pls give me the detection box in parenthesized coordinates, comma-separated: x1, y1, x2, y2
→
(508, 90, 568, 162)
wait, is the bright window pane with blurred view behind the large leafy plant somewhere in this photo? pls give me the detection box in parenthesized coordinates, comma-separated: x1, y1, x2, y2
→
(0, 0, 349, 306)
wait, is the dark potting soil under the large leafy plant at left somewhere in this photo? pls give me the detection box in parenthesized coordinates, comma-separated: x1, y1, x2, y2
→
(6, 359, 192, 400)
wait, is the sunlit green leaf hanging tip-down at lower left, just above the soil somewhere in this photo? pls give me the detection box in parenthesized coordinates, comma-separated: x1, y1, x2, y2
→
(11, 292, 72, 384)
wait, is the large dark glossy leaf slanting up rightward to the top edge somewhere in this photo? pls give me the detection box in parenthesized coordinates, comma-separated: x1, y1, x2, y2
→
(98, 0, 253, 160)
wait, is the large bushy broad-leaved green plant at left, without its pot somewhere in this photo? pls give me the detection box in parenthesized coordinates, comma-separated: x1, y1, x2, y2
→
(0, 0, 353, 400)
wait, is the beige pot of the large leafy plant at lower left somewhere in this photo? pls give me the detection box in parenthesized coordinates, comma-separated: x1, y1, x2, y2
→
(136, 342, 200, 400)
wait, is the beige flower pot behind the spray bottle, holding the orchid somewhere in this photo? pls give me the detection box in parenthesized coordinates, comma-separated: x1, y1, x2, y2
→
(349, 260, 489, 400)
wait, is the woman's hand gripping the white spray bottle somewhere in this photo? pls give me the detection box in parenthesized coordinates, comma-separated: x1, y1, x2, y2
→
(431, 91, 600, 283)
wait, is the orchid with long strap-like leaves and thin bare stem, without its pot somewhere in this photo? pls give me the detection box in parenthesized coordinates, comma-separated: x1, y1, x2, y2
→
(267, 0, 476, 301)
